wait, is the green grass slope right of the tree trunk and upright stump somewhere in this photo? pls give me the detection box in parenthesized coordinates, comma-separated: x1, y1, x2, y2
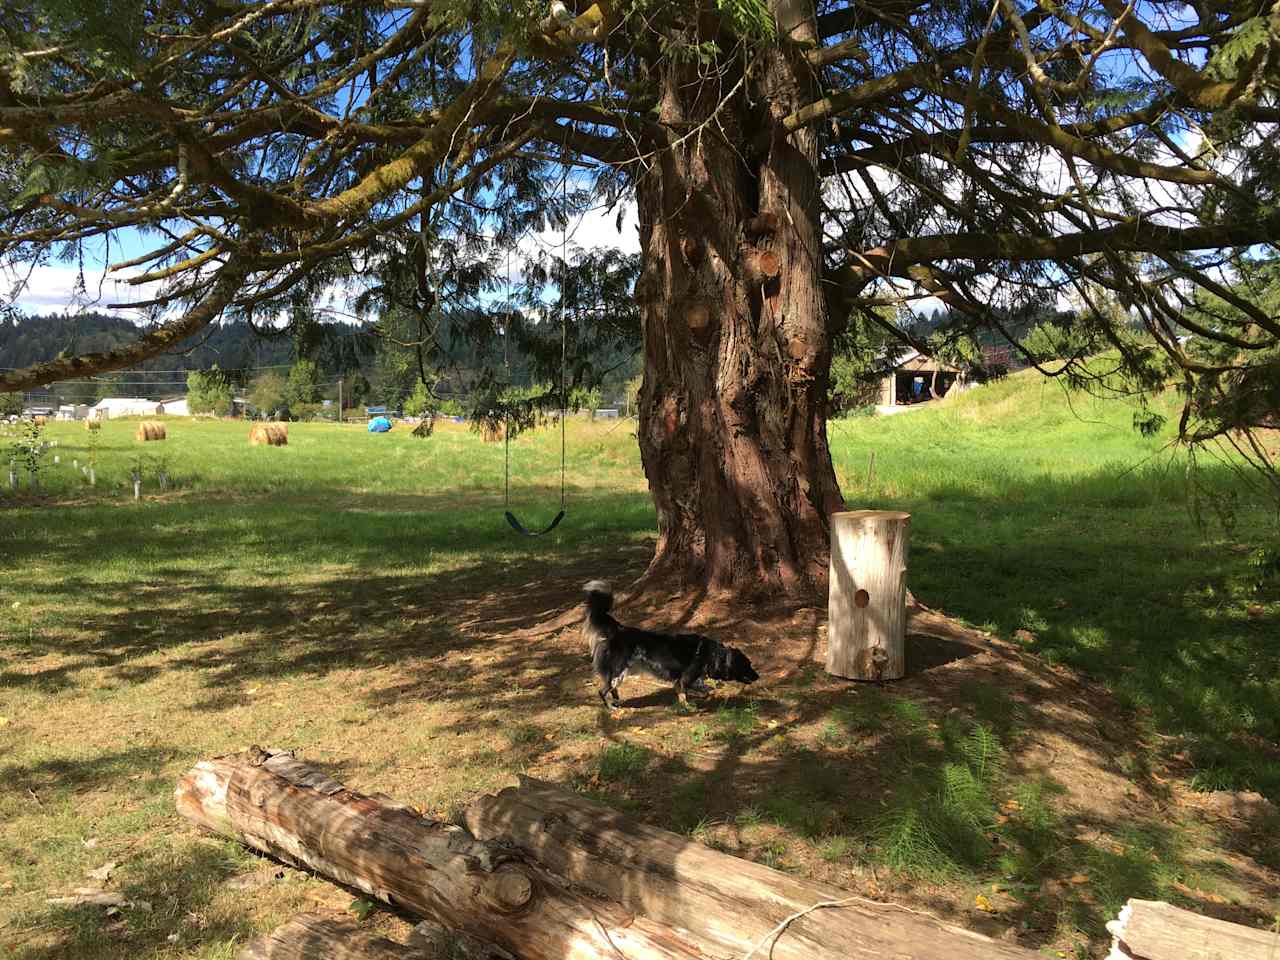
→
(831, 372, 1280, 799)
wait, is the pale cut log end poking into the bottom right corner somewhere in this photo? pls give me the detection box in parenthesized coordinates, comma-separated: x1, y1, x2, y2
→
(1107, 900, 1280, 960)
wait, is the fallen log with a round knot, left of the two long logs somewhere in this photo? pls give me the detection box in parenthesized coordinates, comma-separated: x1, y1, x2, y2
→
(174, 748, 705, 960)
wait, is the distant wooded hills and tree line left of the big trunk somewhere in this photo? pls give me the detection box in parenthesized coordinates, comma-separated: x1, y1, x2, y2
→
(0, 310, 639, 416)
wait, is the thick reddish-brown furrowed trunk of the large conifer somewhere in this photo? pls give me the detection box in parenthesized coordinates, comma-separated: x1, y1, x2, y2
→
(636, 0, 844, 595)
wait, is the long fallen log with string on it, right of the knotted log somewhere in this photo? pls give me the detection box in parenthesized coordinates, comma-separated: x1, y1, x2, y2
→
(466, 777, 1039, 960)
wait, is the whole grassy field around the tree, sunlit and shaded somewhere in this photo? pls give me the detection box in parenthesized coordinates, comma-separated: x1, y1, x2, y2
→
(0, 375, 1280, 960)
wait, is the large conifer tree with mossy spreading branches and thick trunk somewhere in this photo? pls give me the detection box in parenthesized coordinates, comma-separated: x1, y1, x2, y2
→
(0, 0, 1280, 591)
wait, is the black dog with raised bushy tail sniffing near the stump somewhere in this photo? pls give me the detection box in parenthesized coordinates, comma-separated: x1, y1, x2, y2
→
(582, 580, 760, 707)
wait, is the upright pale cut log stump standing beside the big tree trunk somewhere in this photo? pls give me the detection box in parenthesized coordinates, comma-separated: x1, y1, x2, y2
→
(827, 509, 911, 680)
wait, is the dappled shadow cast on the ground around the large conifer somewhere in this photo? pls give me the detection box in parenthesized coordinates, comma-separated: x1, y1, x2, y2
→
(4, 465, 1280, 957)
